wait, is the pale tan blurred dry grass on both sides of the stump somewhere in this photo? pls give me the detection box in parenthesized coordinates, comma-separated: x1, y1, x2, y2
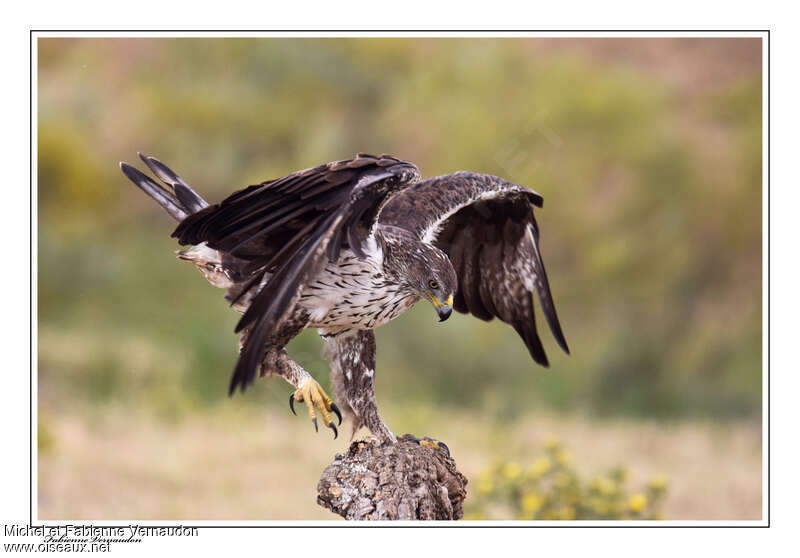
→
(38, 407, 761, 520)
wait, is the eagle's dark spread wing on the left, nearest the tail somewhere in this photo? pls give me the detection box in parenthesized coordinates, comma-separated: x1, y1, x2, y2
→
(172, 153, 420, 393)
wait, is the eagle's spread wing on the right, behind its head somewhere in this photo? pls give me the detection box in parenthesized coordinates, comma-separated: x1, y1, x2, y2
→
(380, 172, 569, 366)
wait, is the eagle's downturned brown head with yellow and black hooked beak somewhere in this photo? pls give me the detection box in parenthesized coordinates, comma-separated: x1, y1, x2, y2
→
(406, 242, 458, 322)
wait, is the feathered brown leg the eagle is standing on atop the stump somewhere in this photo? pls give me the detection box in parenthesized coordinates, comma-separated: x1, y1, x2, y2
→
(323, 330, 397, 442)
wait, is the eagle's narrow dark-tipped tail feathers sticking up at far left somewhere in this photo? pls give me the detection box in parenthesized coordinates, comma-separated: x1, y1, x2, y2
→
(119, 153, 208, 221)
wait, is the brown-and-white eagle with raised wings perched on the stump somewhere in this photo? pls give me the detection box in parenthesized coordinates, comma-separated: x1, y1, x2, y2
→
(120, 153, 569, 441)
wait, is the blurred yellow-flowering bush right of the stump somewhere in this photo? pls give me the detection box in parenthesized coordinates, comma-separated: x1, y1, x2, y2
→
(464, 439, 667, 520)
